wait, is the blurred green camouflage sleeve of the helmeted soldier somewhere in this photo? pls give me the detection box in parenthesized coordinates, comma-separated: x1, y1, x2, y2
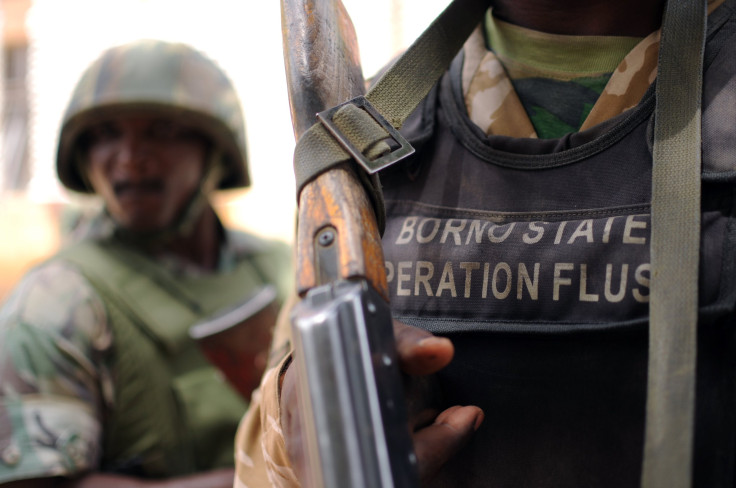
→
(0, 262, 112, 484)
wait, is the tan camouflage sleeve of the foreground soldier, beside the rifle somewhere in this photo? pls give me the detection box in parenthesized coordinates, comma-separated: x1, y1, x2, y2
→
(233, 296, 300, 488)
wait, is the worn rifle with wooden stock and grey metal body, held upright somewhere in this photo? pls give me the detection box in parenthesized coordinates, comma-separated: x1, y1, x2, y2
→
(281, 0, 418, 488)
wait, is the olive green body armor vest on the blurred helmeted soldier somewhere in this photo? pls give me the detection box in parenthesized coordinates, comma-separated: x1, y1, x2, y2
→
(58, 236, 269, 477)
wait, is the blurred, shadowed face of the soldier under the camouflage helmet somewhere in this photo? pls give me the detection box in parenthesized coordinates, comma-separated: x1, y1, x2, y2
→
(86, 115, 208, 232)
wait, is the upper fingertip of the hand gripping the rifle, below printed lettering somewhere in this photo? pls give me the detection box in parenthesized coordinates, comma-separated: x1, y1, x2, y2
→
(394, 320, 455, 375)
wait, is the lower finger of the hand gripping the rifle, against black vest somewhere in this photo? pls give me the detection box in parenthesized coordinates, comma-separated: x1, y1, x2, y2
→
(414, 406, 484, 481)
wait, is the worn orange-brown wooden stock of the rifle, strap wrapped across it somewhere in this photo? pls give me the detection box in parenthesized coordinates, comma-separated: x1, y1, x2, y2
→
(281, 0, 388, 300)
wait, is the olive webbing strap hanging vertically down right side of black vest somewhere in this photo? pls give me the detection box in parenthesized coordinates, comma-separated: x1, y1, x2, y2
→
(642, 0, 706, 488)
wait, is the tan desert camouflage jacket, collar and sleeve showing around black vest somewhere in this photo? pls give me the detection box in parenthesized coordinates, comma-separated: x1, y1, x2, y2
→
(234, 0, 728, 488)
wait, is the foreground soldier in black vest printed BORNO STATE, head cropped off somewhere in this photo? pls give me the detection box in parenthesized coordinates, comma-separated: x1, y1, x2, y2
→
(237, 0, 736, 488)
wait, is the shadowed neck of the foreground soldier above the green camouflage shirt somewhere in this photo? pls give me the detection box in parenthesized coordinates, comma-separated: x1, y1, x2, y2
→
(493, 0, 665, 37)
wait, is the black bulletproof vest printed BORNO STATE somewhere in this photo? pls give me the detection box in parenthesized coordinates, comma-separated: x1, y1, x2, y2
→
(381, 0, 736, 488)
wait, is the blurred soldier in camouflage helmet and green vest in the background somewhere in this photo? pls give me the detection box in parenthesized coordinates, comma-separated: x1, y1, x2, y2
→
(0, 40, 291, 487)
